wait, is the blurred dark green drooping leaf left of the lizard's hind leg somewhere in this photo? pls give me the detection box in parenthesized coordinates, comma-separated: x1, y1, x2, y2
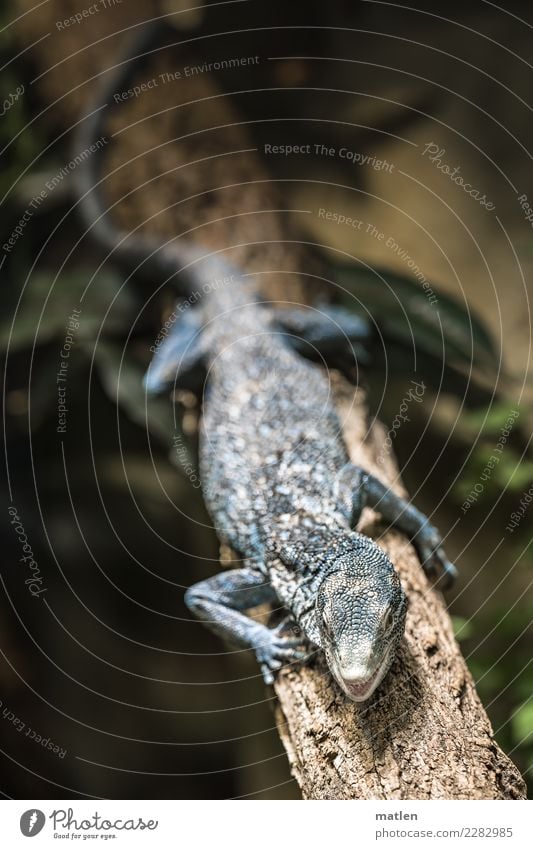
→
(0, 266, 186, 458)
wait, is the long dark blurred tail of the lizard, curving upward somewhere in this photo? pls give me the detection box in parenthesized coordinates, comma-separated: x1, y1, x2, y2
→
(73, 21, 205, 291)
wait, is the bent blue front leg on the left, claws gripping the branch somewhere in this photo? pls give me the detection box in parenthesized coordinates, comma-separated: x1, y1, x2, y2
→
(185, 568, 306, 684)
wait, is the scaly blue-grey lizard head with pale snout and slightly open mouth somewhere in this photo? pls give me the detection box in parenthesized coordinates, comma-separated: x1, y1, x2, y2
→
(315, 539, 407, 702)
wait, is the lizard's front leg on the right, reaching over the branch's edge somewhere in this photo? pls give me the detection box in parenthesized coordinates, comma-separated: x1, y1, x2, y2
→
(336, 463, 457, 587)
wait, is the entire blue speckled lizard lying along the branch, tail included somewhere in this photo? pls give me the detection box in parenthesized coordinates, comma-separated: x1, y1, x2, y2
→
(80, 21, 455, 701)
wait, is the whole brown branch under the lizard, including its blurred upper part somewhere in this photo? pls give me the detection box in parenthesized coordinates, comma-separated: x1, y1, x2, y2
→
(15, 0, 525, 799)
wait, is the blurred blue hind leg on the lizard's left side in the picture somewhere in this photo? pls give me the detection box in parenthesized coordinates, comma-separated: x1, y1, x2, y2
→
(144, 306, 206, 394)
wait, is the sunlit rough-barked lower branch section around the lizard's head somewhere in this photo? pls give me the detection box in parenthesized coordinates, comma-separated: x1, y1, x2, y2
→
(275, 377, 525, 799)
